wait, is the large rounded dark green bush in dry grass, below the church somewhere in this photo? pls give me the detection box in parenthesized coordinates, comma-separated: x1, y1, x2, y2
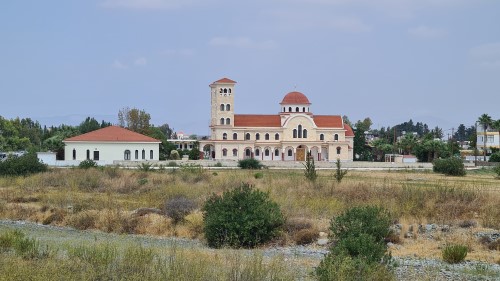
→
(202, 184, 284, 248)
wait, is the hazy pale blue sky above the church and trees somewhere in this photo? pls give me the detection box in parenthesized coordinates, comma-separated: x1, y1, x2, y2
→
(0, 0, 500, 135)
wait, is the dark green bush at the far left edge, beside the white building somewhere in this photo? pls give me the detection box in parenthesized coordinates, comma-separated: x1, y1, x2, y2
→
(0, 153, 48, 176)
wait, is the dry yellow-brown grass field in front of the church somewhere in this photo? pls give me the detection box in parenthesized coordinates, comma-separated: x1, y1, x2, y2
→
(0, 164, 500, 263)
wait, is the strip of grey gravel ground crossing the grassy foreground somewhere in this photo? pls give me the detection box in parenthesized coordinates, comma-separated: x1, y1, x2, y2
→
(0, 220, 500, 281)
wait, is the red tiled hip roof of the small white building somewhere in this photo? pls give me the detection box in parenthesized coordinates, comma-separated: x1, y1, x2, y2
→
(64, 126, 160, 143)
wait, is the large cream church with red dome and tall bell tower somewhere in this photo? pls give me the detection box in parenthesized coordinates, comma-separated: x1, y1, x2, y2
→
(200, 78, 354, 161)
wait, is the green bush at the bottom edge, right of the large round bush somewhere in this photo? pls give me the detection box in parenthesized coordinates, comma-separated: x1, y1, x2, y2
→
(315, 206, 395, 280)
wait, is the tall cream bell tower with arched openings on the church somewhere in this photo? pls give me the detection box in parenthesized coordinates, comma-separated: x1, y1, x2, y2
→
(210, 78, 236, 130)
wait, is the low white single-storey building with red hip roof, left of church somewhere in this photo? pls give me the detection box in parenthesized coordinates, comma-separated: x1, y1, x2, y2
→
(63, 126, 161, 165)
